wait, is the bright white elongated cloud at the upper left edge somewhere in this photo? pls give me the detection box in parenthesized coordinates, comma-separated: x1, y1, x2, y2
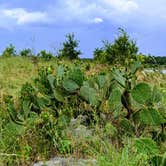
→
(0, 8, 47, 25)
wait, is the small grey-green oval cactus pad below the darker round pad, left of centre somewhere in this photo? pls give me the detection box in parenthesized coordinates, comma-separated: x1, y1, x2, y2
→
(63, 79, 79, 92)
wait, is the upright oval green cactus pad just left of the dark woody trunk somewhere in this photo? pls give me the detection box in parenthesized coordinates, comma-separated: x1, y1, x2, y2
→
(109, 89, 122, 111)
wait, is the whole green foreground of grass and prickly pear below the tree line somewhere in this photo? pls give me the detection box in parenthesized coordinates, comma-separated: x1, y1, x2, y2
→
(0, 57, 166, 166)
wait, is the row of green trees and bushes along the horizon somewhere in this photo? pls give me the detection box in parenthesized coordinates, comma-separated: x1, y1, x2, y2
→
(2, 28, 166, 66)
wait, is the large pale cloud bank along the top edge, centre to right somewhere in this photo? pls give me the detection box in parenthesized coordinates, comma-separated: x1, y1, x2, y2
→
(45, 0, 139, 23)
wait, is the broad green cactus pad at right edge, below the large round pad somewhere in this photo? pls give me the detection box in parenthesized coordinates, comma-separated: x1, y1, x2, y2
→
(140, 109, 166, 125)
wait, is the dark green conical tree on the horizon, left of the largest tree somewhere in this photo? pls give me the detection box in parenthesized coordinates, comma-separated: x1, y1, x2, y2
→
(58, 33, 81, 60)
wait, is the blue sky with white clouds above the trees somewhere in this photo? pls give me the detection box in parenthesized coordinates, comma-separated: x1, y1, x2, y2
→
(0, 0, 166, 57)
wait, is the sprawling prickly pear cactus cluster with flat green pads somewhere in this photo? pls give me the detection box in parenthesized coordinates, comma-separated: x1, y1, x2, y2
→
(4, 61, 165, 128)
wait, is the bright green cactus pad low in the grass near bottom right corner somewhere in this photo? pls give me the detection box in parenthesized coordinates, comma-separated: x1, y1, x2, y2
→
(134, 138, 160, 156)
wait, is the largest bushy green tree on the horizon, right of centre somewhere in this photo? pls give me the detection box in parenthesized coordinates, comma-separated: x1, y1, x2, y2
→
(94, 28, 138, 65)
